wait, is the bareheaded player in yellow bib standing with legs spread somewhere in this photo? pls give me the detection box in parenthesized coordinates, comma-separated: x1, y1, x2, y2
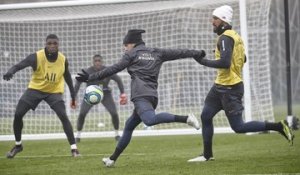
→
(3, 34, 80, 158)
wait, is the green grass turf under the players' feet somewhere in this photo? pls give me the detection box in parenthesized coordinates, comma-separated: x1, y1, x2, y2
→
(0, 131, 300, 175)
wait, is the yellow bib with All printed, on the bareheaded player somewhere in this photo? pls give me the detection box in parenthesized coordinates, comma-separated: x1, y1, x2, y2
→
(28, 49, 66, 93)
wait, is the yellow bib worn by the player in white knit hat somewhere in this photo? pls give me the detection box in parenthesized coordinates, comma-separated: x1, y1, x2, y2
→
(215, 30, 245, 85)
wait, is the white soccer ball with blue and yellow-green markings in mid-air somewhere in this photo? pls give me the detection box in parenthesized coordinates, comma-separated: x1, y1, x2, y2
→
(84, 85, 103, 105)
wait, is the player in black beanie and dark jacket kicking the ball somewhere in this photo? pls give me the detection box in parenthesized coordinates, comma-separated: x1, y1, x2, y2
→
(76, 30, 205, 167)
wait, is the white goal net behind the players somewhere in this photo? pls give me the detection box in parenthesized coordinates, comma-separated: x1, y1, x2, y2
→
(0, 0, 274, 139)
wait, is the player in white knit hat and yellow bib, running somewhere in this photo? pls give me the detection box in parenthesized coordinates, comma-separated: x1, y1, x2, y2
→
(188, 5, 294, 162)
